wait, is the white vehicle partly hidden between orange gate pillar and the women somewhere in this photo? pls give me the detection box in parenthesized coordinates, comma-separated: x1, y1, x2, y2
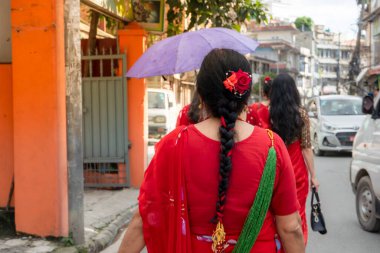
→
(147, 88, 178, 138)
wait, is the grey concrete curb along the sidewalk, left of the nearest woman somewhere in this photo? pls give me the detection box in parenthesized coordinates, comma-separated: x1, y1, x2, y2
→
(85, 204, 138, 253)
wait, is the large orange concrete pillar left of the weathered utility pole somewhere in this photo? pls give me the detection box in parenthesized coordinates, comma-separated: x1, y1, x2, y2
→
(11, 0, 68, 236)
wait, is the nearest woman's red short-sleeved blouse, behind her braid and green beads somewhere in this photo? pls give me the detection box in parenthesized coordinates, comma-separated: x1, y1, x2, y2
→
(185, 125, 299, 252)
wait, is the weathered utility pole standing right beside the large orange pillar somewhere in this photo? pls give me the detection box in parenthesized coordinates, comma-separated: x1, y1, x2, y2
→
(64, 0, 85, 244)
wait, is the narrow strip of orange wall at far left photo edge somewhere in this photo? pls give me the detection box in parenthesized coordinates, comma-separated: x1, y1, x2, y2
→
(0, 64, 13, 207)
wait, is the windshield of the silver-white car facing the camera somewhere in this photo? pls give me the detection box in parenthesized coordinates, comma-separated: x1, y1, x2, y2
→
(321, 99, 363, 115)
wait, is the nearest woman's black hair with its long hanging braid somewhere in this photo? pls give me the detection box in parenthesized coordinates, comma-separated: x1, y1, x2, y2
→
(197, 49, 251, 223)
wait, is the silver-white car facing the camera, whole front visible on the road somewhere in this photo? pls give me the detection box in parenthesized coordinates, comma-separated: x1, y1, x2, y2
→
(306, 95, 365, 156)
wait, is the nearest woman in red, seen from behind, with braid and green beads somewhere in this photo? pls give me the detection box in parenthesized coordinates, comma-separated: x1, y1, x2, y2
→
(119, 49, 305, 253)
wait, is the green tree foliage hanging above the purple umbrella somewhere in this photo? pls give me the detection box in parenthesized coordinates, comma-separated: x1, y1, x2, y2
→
(166, 0, 269, 36)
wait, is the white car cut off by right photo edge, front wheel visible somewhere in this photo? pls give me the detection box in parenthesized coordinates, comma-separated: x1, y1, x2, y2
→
(350, 97, 380, 232)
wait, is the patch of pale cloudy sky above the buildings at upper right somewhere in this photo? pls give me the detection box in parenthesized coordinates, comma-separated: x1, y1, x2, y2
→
(271, 0, 360, 39)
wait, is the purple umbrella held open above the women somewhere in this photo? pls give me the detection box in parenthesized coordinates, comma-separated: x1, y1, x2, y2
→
(126, 28, 259, 78)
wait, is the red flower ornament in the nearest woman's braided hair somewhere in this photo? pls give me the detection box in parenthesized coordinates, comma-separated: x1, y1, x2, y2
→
(223, 69, 252, 98)
